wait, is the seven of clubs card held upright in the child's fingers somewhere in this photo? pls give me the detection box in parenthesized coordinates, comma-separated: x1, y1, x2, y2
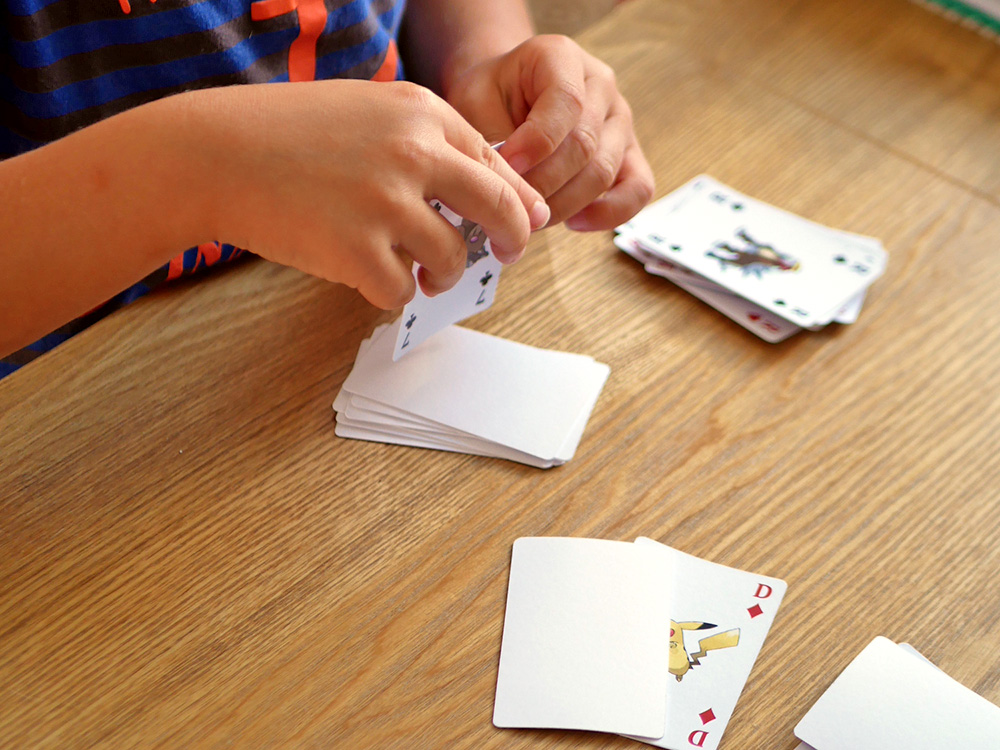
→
(392, 200, 502, 361)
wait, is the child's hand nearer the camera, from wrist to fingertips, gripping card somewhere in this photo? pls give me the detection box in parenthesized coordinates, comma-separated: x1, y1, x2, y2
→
(180, 80, 549, 309)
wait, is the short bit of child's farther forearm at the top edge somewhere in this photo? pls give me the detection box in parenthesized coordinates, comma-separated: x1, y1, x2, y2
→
(402, 0, 534, 97)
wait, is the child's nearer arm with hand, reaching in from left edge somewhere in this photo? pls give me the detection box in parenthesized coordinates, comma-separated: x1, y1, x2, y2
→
(0, 81, 548, 355)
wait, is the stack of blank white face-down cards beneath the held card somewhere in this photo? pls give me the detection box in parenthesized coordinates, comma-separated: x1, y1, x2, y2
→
(334, 326, 609, 465)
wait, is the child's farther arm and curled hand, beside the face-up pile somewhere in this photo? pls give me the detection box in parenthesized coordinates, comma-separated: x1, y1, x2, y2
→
(404, 0, 653, 230)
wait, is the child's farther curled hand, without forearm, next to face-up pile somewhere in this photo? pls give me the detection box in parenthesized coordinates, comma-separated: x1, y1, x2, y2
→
(448, 36, 653, 230)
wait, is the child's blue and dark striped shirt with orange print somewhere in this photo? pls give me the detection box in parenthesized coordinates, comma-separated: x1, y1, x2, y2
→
(0, 0, 405, 377)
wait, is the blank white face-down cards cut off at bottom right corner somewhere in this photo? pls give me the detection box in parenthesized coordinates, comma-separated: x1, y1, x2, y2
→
(795, 637, 1000, 750)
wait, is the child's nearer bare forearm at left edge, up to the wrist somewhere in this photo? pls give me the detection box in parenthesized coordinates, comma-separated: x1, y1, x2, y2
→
(0, 95, 214, 355)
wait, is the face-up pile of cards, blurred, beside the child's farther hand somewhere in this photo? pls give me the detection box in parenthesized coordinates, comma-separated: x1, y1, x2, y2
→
(615, 175, 887, 343)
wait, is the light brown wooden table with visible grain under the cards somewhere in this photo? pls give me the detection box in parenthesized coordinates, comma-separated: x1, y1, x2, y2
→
(0, 0, 1000, 750)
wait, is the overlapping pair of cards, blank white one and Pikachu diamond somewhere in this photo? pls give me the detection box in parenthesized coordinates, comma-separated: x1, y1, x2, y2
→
(493, 537, 785, 750)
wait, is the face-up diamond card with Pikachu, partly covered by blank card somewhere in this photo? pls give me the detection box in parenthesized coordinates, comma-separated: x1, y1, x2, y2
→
(636, 537, 786, 750)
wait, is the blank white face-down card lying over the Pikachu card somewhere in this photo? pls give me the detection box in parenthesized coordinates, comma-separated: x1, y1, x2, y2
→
(493, 537, 671, 736)
